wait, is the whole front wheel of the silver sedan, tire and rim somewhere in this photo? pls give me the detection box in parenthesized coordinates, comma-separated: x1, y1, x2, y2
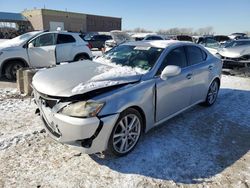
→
(108, 108, 142, 157)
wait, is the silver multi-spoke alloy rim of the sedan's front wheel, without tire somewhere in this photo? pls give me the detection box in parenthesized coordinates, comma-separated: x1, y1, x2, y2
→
(113, 114, 141, 153)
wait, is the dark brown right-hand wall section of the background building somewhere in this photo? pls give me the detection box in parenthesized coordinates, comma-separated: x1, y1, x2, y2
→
(87, 14, 121, 32)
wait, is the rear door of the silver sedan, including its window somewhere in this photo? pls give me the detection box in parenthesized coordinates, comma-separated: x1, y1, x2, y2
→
(185, 46, 211, 104)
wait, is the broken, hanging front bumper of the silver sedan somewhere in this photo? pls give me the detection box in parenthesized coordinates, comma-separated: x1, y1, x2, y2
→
(35, 93, 119, 154)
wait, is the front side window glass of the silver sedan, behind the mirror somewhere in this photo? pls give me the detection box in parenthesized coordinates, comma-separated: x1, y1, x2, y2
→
(157, 47, 187, 75)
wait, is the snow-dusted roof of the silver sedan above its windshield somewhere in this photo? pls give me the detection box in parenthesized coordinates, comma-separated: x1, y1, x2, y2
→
(123, 40, 193, 48)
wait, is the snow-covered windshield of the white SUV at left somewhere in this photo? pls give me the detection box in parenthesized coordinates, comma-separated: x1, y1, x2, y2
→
(0, 31, 41, 46)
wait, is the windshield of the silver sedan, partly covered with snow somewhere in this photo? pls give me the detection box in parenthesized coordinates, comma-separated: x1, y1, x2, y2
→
(96, 45, 163, 71)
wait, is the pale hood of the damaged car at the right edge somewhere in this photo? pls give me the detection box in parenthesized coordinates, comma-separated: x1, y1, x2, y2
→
(219, 46, 250, 58)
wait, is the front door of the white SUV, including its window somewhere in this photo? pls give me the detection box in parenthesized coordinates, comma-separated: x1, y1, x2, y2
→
(27, 33, 56, 67)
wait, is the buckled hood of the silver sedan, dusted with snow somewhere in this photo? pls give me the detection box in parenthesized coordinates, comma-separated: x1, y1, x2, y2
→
(32, 60, 141, 97)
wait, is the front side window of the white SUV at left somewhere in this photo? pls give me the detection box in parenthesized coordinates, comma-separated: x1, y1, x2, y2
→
(31, 33, 56, 47)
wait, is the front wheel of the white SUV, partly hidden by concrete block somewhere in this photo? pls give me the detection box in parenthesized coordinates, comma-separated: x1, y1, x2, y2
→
(5, 61, 24, 80)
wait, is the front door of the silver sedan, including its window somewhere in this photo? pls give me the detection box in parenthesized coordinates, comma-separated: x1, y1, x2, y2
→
(156, 47, 193, 122)
